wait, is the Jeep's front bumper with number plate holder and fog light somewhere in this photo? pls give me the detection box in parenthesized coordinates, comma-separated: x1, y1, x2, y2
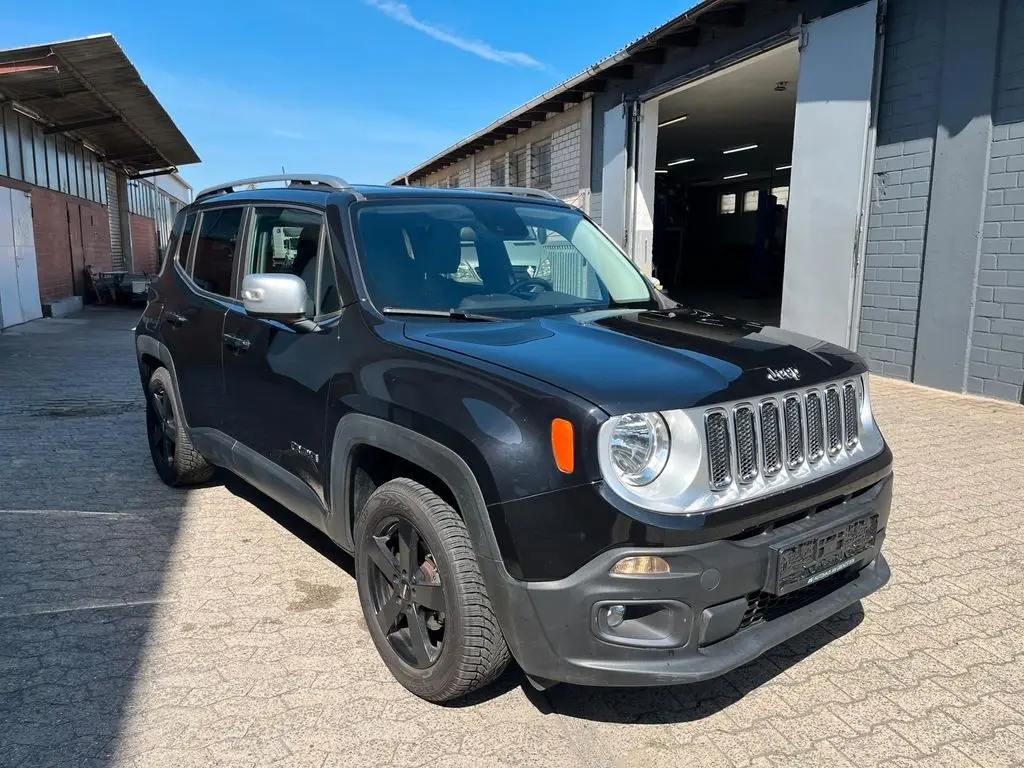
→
(483, 449, 893, 686)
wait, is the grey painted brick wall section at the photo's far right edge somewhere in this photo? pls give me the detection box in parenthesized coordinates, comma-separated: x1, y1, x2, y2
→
(967, 0, 1024, 402)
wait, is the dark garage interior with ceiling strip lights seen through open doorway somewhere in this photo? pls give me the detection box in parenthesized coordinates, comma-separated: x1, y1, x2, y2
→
(652, 42, 800, 325)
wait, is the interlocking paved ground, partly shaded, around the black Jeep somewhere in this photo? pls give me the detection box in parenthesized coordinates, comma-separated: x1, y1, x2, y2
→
(0, 310, 1024, 768)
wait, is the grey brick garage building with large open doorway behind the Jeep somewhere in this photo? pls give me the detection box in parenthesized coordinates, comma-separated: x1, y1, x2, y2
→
(391, 0, 1024, 402)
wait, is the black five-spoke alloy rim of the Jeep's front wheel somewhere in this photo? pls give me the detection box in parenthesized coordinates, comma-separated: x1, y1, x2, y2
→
(366, 517, 445, 670)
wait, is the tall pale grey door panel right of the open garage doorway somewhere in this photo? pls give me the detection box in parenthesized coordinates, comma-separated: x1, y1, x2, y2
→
(781, 0, 878, 345)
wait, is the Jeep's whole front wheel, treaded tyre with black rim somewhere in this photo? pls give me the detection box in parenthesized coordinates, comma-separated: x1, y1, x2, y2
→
(354, 478, 509, 702)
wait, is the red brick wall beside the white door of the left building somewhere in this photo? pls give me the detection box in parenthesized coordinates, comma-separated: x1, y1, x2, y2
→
(0, 176, 111, 304)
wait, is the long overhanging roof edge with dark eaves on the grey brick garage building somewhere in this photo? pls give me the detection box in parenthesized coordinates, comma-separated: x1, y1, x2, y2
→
(388, 0, 748, 184)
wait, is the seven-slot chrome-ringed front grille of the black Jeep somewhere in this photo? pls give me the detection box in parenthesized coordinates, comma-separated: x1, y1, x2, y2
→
(705, 381, 860, 490)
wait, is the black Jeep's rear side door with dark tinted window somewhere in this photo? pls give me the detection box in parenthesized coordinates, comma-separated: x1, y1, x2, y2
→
(160, 206, 246, 429)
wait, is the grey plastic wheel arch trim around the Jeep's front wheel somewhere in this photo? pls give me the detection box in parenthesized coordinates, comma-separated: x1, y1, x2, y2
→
(328, 414, 500, 560)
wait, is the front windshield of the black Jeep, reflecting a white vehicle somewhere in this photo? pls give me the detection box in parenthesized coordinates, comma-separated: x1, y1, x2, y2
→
(355, 199, 655, 317)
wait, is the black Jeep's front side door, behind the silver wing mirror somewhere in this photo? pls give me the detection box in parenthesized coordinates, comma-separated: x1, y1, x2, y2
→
(223, 206, 341, 511)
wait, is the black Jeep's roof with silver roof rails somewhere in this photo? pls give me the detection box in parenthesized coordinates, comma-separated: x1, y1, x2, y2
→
(191, 184, 570, 208)
